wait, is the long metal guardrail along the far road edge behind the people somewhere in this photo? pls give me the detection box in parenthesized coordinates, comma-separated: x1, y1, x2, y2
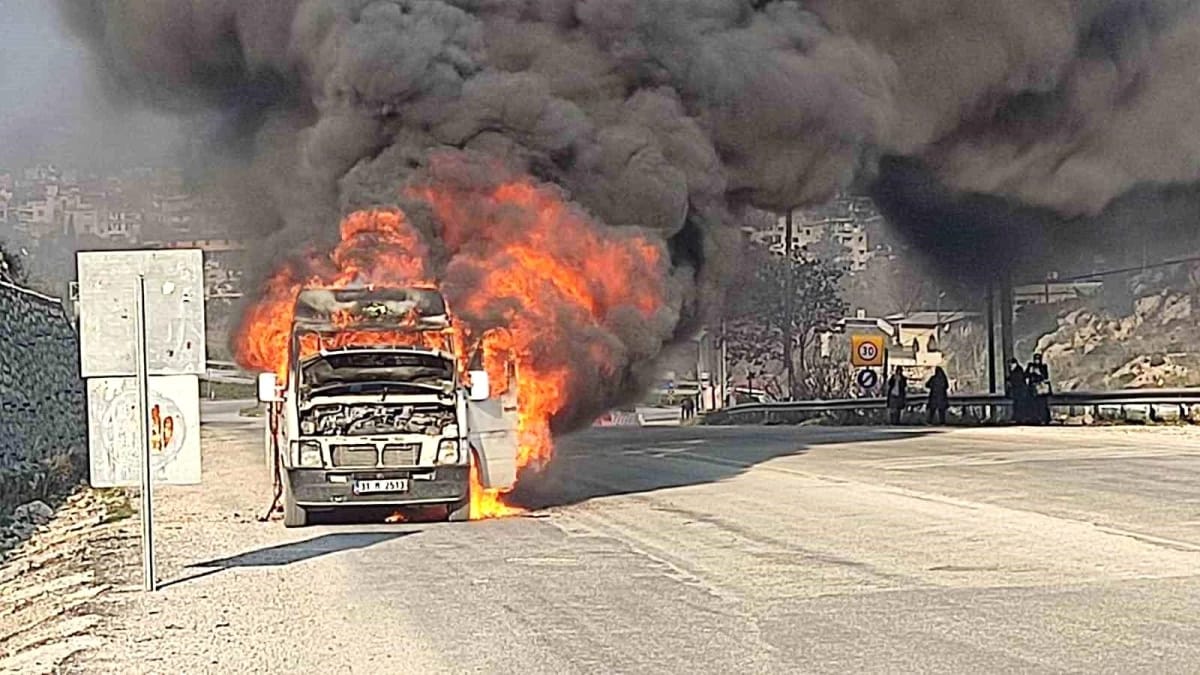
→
(707, 388, 1200, 424)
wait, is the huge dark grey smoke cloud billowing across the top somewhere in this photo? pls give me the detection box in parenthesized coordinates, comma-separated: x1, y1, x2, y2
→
(62, 0, 1200, 413)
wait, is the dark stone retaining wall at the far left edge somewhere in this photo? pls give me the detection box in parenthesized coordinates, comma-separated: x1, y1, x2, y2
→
(0, 281, 88, 516)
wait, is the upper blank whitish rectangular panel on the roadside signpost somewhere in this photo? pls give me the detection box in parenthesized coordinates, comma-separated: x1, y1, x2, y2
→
(78, 250, 205, 377)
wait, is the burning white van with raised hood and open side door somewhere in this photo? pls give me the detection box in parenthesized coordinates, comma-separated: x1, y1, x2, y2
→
(258, 287, 518, 527)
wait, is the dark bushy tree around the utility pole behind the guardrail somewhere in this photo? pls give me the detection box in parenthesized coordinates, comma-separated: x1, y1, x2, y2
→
(725, 247, 846, 396)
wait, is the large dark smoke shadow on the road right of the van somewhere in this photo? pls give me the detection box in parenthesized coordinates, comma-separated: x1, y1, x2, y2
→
(512, 426, 938, 509)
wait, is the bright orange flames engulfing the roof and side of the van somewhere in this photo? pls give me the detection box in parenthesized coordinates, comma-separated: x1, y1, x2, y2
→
(234, 172, 666, 519)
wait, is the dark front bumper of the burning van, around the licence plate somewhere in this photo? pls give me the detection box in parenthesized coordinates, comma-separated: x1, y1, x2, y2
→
(283, 466, 470, 508)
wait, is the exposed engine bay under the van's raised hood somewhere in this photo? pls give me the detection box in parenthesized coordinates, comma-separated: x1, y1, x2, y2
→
(300, 404, 455, 436)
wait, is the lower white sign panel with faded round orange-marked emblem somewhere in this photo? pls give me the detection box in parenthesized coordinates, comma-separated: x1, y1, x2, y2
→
(88, 375, 200, 488)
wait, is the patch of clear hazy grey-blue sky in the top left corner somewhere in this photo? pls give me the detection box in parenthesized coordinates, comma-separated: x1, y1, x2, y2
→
(0, 0, 179, 167)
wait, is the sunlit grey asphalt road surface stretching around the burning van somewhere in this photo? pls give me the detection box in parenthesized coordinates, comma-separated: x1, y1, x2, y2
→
(74, 417, 1200, 674)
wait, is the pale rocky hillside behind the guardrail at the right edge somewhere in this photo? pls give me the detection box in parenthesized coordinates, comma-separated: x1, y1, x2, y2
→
(1018, 265, 1200, 390)
